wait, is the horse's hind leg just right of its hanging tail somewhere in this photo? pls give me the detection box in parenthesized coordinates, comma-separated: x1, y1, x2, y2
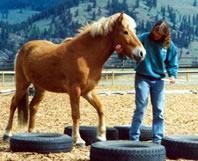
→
(28, 87, 45, 132)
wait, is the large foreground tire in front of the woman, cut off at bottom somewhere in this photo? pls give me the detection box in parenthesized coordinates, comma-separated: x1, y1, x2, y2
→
(90, 140, 166, 161)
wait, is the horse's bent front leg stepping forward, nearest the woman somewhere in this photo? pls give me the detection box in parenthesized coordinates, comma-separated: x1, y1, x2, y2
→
(83, 91, 106, 141)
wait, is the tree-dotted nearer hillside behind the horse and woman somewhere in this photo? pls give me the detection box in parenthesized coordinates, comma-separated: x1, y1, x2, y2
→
(0, 0, 198, 66)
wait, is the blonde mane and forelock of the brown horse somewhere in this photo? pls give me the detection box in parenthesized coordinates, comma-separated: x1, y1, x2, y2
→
(77, 13, 136, 37)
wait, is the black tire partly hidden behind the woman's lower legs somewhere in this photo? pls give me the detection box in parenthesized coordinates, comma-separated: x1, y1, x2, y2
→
(114, 125, 153, 141)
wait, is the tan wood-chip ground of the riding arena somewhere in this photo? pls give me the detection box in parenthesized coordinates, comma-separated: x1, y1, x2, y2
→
(0, 85, 198, 161)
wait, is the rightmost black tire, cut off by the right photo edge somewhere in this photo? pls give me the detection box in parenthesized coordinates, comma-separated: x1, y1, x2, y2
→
(162, 135, 198, 160)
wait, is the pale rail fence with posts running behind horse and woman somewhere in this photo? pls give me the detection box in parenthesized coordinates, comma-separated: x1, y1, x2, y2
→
(0, 70, 198, 86)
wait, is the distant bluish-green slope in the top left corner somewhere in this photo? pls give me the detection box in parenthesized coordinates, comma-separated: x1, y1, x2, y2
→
(0, 0, 62, 24)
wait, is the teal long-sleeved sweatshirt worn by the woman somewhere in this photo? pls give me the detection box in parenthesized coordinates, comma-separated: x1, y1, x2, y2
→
(135, 33, 178, 79)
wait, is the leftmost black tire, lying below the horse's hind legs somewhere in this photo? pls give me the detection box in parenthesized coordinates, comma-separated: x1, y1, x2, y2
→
(10, 133, 73, 153)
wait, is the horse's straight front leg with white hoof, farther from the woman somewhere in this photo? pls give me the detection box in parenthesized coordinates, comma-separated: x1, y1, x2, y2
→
(69, 87, 85, 147)
